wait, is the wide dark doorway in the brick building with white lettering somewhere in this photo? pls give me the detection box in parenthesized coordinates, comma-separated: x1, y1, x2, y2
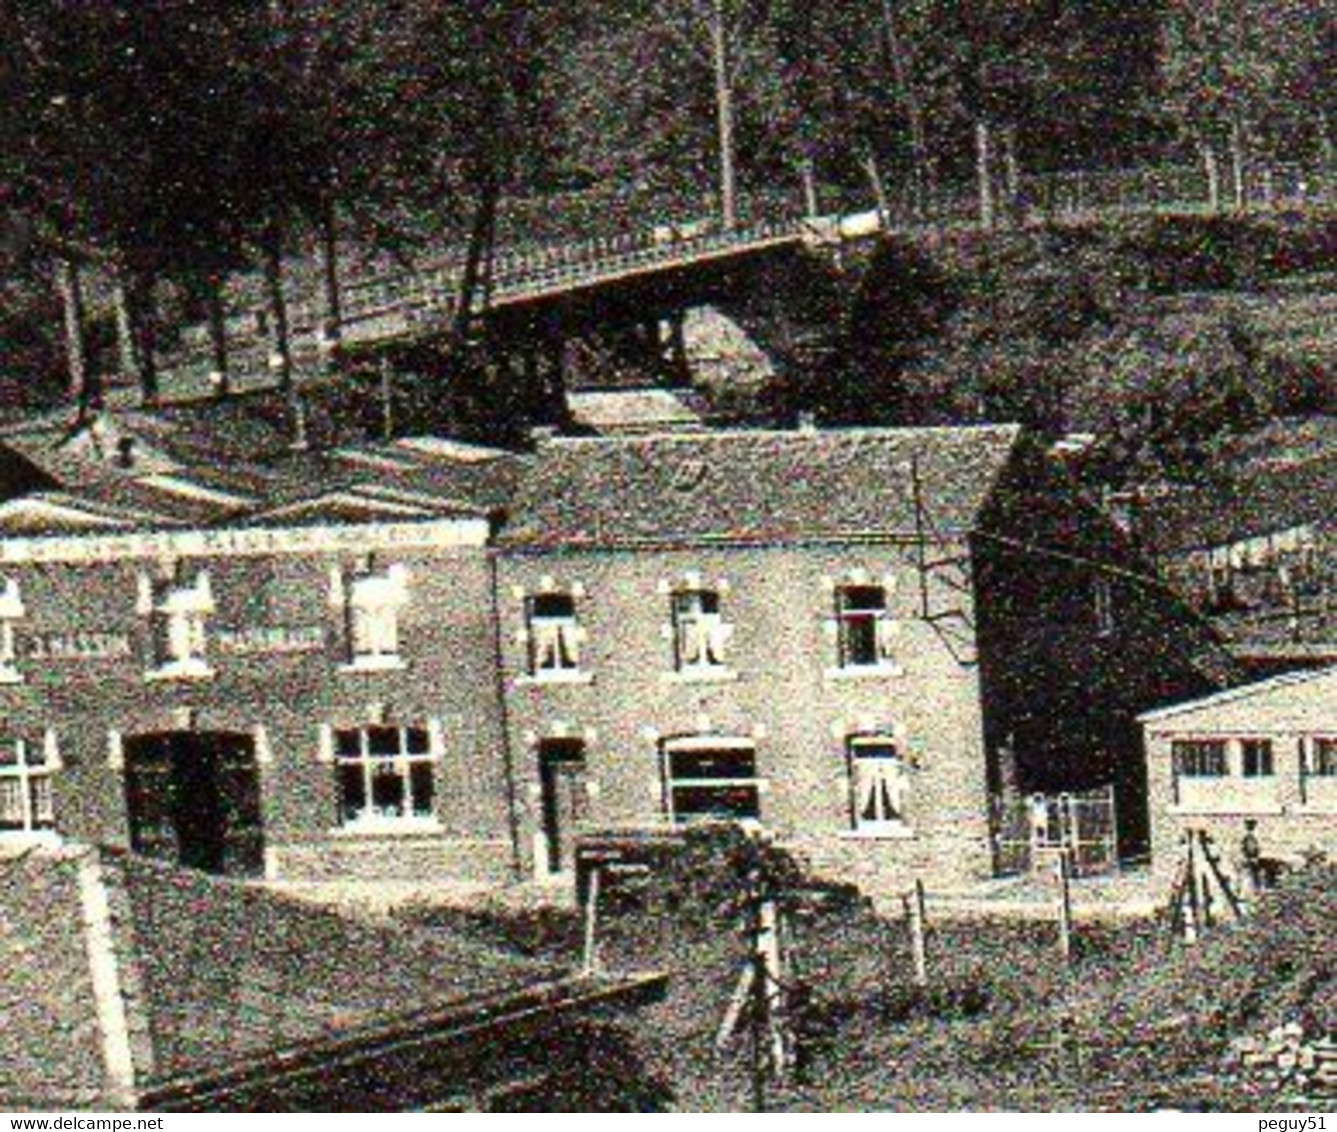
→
(124, 731, 265, 877)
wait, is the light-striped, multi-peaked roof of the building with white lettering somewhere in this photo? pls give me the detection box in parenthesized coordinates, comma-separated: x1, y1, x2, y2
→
(0, 402, 521, 535)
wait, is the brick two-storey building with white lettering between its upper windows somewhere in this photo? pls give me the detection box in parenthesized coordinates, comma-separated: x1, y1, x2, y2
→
(0, 414, 515, 879)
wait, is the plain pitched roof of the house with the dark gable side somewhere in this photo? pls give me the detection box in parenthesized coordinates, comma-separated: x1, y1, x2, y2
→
(500, 425, 1020, 548)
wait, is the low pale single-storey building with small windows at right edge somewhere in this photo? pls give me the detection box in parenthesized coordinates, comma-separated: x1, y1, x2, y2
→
(1142, 667, 1337, 873)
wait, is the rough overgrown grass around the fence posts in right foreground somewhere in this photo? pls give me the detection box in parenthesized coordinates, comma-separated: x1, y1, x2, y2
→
(403, 866, 1337, 1111)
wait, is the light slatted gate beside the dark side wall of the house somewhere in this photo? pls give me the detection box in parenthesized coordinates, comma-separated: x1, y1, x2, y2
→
(993, 786, 1119, 877)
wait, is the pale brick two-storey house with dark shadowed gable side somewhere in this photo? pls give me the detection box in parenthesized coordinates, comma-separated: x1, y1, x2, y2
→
(496, 426, 1229, 890)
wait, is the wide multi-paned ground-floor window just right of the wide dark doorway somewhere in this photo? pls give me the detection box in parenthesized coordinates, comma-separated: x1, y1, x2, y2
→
(333, 724, 437, 830)
